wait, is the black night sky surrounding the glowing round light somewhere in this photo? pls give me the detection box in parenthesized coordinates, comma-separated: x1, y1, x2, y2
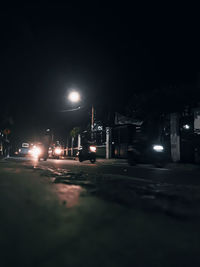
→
(0, 4, 200, 141)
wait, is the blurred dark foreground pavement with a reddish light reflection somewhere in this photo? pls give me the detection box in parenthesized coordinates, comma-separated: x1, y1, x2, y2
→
(0, 158, 200, 266)
